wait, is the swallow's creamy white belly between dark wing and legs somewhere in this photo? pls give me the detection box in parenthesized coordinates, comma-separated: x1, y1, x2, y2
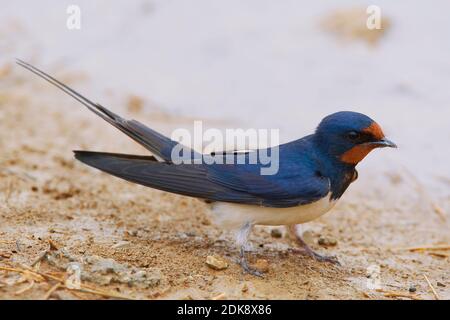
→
(212, 194, 336, 229)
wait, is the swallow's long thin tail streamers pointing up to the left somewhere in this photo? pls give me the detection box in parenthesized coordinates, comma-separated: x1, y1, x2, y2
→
(17, 59, 199, 162)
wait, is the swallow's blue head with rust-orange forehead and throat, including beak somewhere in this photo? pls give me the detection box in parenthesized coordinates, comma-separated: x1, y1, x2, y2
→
(315, 111, 397, 166)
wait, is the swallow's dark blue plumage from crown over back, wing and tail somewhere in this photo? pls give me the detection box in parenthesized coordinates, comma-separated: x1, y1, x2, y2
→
(19, 61, 398, 208)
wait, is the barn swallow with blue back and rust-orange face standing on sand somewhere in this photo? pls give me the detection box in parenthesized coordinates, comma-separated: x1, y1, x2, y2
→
(17, 60, 397, 276)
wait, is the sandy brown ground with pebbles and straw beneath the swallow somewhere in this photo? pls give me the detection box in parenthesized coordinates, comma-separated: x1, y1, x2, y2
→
(0, 65, 450, 299)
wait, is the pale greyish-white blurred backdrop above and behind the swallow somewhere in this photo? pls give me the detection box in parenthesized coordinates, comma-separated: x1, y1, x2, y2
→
(0, 0, 450, 198)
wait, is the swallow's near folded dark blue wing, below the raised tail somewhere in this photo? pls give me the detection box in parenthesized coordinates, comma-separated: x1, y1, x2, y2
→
(75, 151, 329, 207)
